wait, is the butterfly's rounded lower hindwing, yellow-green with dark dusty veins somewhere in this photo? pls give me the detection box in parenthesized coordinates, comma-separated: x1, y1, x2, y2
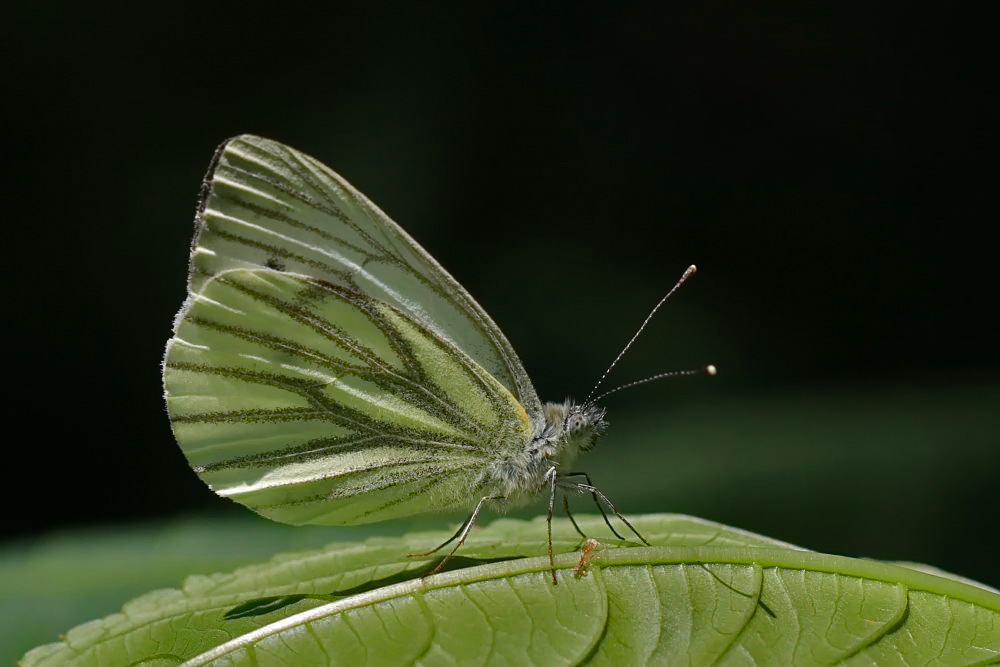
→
(164, 269, 531, 524)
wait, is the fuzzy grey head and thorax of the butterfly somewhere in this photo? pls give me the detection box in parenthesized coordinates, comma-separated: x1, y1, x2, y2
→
(486, 399, 607, 505)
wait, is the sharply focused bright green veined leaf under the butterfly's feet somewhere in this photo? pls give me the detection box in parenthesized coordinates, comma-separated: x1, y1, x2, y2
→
(24, 515, 1000, 665)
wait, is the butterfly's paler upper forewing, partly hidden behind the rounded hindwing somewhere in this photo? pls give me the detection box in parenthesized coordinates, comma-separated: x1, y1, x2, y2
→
(190, 135, 541, 415)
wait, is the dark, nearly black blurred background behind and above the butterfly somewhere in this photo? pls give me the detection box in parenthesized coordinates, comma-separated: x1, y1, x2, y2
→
(3, 2, 1000, 585)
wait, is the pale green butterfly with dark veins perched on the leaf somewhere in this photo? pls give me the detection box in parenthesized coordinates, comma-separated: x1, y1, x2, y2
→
(163, 136, 714, 580)
